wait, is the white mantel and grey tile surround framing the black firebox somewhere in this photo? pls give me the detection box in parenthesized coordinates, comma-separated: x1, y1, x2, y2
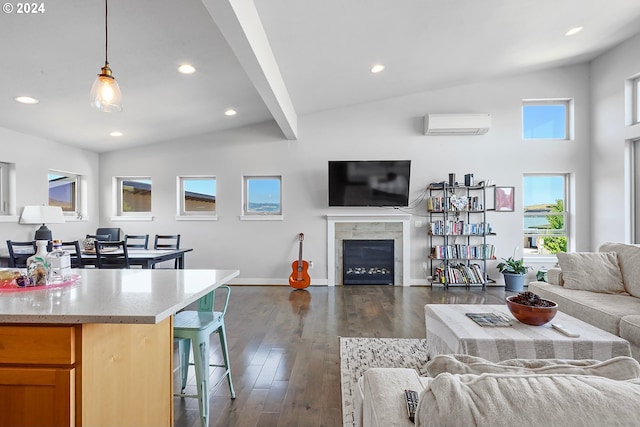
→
(327, 214, 411, 286)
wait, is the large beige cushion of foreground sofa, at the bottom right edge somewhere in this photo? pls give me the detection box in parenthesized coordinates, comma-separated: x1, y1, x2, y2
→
(415, 373, 640, 427)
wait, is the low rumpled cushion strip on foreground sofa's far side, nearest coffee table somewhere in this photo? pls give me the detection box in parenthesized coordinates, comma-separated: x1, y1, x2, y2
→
(426, 354, 640, 380)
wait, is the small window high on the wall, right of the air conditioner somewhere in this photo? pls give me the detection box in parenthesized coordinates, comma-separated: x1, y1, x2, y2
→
(522, 100, 572, 140)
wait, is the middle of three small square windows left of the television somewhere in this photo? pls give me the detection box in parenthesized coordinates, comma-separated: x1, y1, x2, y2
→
(178, 176, 216, 218)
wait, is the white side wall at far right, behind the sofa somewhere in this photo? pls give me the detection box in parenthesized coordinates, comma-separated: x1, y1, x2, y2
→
(591, 35, 640, 250)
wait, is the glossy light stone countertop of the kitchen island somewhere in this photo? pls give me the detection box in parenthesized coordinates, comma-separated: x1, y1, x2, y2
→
(0, 269, 239, 324)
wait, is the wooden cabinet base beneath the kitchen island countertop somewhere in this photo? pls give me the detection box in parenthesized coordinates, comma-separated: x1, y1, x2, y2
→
(0, 316, 173, 427)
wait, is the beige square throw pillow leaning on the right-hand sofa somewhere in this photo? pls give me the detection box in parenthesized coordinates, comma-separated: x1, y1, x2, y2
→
(556, 252, 627, 294)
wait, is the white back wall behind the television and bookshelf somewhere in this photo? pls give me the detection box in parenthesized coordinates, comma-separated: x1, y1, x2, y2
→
(100, 65, 591, 284)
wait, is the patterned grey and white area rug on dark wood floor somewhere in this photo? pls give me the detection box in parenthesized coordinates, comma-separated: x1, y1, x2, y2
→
(340, 337, 429, 427)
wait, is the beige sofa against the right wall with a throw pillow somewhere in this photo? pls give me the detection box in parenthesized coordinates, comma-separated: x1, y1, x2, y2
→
(528, 243, 640, 360)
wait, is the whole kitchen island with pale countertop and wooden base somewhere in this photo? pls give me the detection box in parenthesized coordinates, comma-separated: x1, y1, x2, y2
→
(0, 269, 239, 427)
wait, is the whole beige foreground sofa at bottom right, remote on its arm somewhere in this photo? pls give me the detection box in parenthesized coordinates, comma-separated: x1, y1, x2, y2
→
(356, 355, 640, 427)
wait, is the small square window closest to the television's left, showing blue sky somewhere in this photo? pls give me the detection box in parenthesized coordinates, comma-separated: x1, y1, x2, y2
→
(242, 176, 282, 217)
